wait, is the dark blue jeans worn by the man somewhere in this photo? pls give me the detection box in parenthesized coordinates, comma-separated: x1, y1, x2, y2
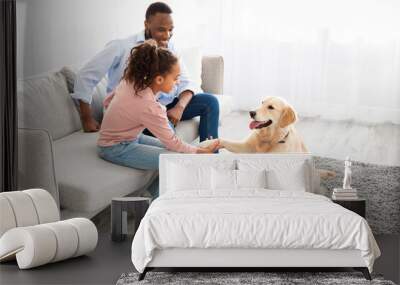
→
(143, 93, 219, 142)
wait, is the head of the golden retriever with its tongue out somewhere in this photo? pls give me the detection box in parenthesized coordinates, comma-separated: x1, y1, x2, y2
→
(249, 97, 297, 129)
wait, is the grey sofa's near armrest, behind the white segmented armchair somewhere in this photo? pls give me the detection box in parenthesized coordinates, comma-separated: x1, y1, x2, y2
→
(18, 128, 60, 207)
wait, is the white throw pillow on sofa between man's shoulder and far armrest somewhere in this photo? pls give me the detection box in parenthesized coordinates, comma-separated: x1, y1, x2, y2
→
(179, 47, 202, 92)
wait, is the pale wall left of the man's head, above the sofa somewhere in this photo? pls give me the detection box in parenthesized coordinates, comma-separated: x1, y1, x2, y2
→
(17, 0, 153, 78)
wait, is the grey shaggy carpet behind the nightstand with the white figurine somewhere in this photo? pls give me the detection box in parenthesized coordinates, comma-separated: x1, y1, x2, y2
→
(314, 156, 400, 234)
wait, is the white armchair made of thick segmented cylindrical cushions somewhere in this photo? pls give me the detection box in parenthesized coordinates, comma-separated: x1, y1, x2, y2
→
(0, 189, 98, 269)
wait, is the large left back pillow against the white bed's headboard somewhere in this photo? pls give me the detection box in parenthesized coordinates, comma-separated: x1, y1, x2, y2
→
(167, 163, 211, 191)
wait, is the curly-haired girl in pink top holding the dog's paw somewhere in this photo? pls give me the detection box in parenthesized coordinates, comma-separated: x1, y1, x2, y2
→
(97, 41, 218, 195)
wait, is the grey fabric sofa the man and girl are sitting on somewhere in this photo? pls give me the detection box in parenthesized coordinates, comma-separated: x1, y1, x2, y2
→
(18, 56, 232, 218)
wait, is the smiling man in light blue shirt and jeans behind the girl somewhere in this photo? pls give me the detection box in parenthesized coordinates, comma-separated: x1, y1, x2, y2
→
(72, 2, 219, 141)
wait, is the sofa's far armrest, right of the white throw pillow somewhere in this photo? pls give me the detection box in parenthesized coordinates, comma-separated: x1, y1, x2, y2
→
(201, 56, 224, 94)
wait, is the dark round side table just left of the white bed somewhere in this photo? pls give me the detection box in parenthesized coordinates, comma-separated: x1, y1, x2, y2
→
(111, 197, 151, 241)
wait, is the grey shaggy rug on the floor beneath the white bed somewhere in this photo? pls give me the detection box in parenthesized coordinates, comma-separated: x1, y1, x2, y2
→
(117, 272, 395, 285)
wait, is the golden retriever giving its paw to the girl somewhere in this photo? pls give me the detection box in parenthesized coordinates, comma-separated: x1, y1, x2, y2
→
(202, 97, 336, 178)
